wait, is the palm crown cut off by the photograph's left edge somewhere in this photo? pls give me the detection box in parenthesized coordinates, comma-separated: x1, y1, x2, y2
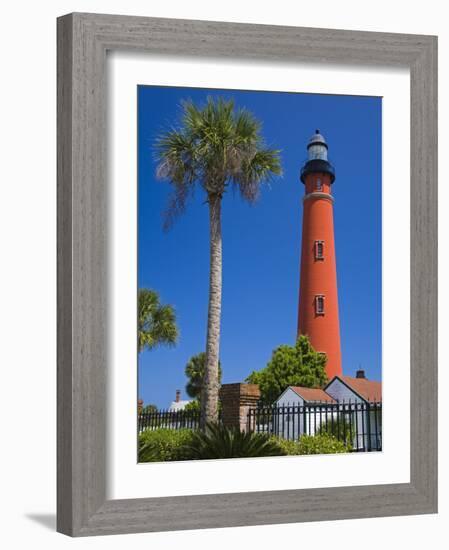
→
(138, 288, 178, 352)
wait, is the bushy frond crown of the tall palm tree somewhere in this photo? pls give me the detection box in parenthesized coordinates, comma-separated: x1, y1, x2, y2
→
(156, 97, 282, 229)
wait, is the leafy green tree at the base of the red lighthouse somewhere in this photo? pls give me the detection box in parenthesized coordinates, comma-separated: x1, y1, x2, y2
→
(246, 335, 327, 403)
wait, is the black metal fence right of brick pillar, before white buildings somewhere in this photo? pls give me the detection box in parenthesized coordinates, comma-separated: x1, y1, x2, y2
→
(247, 401, 382, 451)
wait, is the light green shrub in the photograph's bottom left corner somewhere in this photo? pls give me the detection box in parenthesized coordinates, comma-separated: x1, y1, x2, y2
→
(139, 428, 193, 462)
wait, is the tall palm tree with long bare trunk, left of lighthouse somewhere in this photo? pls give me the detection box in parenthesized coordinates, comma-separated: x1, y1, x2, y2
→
(156, 98, 281, 429)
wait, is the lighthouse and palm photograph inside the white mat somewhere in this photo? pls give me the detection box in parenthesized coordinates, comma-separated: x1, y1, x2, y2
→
(137, 85, 382, 462)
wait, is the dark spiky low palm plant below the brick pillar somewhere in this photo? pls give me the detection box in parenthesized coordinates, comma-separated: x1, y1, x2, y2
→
(186, 423, 284, 459)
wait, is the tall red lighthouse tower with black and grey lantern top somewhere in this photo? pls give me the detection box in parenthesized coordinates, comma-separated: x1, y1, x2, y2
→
(298, 130, 342, 379)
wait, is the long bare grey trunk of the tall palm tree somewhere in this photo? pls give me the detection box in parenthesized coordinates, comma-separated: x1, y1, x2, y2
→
(201, 194, 222, 430)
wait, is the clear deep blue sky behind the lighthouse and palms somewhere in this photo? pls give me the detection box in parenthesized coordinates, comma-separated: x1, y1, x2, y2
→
(138, 86, 382, 408)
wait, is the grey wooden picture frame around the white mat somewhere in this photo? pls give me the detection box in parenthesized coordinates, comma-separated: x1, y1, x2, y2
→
(57, 13, 437, 536)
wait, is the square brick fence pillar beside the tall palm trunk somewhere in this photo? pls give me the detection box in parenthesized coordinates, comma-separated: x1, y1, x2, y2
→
(220, 383, 260, 432)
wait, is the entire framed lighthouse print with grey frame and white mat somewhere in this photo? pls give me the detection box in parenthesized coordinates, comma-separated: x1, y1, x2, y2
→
(58, 14, 437, 536)
